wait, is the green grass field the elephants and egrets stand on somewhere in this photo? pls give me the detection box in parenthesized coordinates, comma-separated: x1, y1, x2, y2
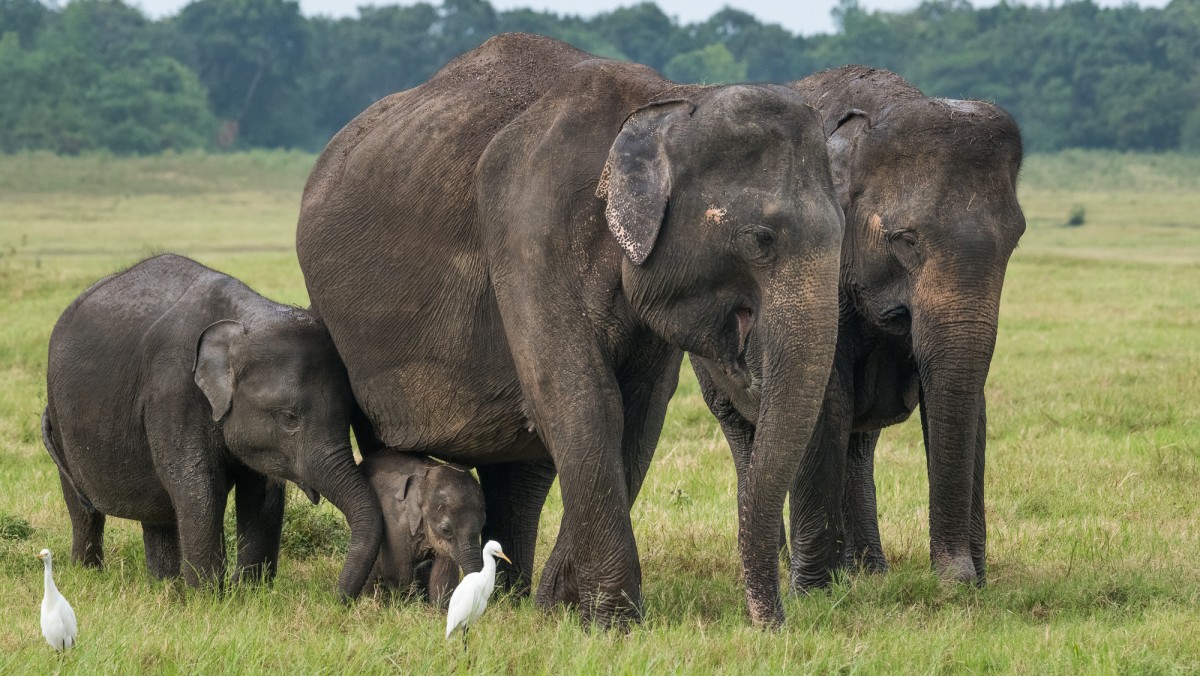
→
(0, 152, 1200, 674)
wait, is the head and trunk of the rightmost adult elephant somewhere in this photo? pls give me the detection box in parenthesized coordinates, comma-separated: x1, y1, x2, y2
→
(826, 92, 1025, 581)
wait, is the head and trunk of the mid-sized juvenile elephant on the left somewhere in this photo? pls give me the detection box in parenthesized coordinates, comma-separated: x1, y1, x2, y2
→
(193, 307, 383, 599)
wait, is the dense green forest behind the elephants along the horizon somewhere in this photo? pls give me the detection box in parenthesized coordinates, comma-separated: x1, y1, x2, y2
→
(0, 0, 1200, 154)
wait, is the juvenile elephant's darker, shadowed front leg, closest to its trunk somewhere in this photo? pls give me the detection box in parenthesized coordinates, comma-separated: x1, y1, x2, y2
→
(233, 471, 287, 585)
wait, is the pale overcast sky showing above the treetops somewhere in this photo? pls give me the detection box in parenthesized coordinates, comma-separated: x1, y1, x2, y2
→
(130, 0, 1168, 35)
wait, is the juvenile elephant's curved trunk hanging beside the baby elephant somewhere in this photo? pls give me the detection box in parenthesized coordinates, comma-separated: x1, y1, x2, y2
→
(312, 449, 383, 602)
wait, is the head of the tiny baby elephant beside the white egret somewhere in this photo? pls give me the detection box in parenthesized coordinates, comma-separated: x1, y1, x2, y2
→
(395, 465, 485, 573)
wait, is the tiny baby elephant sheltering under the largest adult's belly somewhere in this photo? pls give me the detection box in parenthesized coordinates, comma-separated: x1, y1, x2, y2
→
(359, 453, 485, 606)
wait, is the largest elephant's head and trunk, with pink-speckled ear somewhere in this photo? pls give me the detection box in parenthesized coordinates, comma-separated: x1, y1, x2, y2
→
(598, 85, 842, 624)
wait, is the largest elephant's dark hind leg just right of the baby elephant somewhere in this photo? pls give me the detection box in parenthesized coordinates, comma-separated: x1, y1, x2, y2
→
(478, 460, 556, 597)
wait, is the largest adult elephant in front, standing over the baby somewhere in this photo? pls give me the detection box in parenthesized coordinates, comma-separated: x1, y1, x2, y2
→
(296, 34, 842, 626)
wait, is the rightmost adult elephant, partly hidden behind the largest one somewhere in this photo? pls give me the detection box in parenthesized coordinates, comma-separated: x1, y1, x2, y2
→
(696, 66, 1025, 590)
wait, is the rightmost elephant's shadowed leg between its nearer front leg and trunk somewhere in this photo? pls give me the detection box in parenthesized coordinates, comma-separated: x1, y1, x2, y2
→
(842, 430, 888, 573)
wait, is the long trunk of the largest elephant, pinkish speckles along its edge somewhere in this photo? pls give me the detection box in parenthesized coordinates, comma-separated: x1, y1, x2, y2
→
(738, 231, 841, 626)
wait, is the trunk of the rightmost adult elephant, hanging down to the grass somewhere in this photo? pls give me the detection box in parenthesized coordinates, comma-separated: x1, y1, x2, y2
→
(912, 267, 1002, 584)
